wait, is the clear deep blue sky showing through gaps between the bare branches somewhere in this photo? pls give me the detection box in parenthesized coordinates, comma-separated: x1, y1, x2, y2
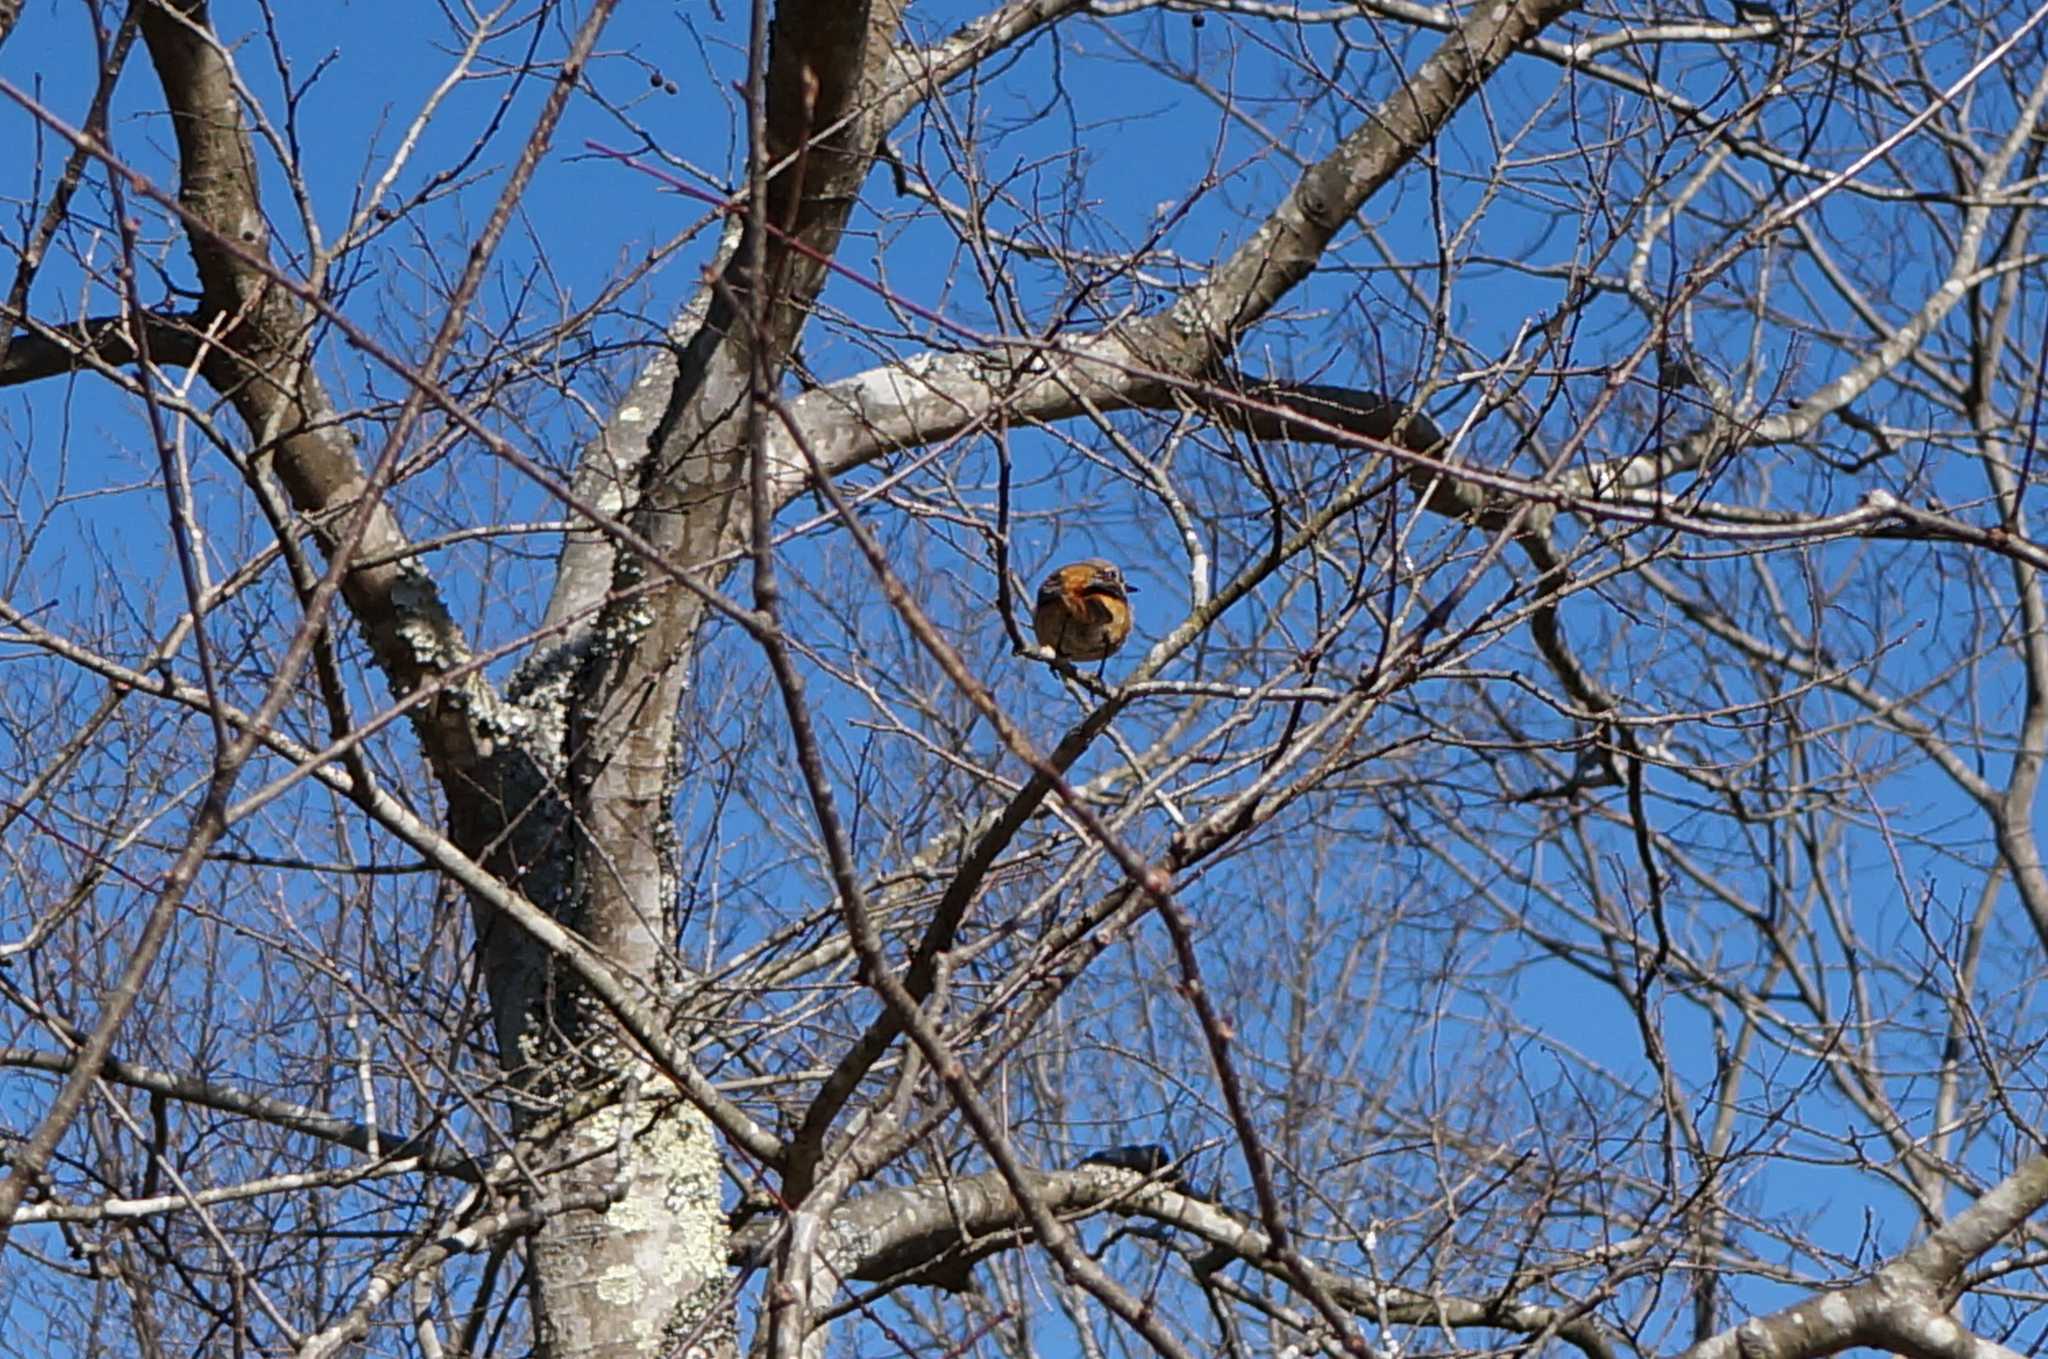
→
(0, 2, 2032, 1350)
